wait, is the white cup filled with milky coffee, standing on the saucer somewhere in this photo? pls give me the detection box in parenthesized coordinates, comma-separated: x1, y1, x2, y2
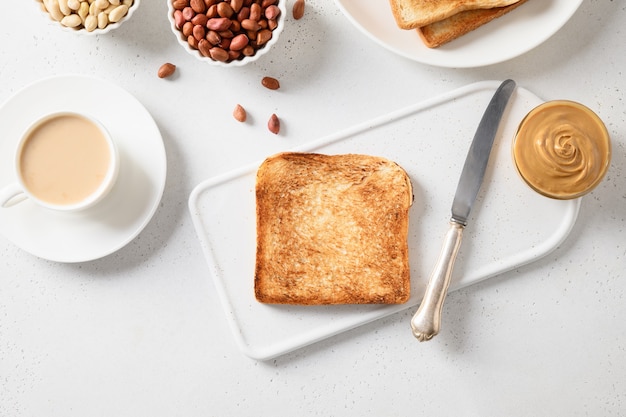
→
(0, 112, 119, 211)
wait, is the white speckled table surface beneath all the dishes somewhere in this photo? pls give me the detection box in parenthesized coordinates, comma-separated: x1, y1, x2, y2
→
(0, 0, 626, 417)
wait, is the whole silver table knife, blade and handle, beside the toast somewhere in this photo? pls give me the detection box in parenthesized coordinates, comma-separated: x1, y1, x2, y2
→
(411, 80, 515, 342)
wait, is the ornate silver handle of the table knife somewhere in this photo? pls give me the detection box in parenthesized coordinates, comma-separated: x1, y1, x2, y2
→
(411, 221, 465, 342)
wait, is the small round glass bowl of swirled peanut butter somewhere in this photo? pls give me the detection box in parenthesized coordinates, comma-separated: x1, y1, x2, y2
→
(513, 101, 611, 199)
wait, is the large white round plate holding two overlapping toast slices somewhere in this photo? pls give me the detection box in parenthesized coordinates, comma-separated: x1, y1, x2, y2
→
(335, 0, 582, 68)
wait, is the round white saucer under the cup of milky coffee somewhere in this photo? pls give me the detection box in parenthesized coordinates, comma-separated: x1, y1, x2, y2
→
(0, 75, 167, 262)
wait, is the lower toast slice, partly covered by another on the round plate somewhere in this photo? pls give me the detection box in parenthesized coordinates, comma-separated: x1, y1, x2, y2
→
(417, 0, 527, 48)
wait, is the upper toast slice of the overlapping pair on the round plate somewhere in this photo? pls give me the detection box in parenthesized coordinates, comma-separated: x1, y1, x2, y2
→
(389, 0, 519, 29)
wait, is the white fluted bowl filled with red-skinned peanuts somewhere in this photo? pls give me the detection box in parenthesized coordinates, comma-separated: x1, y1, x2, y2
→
(167, 0, 286, 67)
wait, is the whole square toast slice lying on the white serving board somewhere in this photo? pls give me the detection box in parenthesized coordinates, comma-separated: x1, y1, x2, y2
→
(254, 152, 413, 305)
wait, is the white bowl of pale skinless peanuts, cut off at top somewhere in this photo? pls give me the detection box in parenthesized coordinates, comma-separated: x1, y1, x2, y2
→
(36, 0, 141, 35)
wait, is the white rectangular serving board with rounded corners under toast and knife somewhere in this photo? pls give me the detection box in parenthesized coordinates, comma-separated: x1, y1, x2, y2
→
(189, 81, 580, 360)
